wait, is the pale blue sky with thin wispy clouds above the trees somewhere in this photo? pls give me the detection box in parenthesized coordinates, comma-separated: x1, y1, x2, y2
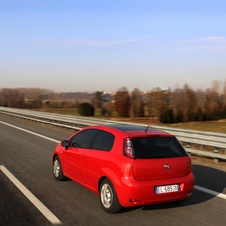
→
(0, 0, 226, 92)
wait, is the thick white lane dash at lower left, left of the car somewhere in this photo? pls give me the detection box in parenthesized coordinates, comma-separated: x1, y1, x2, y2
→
(0, 165, 62, 225)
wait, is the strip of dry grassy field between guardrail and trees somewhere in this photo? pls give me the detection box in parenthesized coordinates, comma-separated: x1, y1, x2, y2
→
(36, 109, 226, 133)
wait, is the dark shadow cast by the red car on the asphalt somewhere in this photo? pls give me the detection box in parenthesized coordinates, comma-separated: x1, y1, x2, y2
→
(121, 164, 226, 213)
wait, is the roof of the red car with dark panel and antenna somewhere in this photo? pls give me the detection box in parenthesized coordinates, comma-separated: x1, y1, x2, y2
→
(101, 125, 173, 137)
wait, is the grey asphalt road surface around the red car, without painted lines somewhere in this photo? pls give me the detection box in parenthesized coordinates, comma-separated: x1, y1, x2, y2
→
(0, 115, 226, 226)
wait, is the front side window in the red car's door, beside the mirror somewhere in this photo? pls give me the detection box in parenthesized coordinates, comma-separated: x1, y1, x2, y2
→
(70, 129, 98, 148)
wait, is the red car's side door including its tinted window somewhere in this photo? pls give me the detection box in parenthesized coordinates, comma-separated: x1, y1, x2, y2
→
(64, 129, 98, 183)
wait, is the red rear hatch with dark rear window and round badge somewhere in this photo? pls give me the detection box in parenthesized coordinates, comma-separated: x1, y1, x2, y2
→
(131, 137, 191, 181)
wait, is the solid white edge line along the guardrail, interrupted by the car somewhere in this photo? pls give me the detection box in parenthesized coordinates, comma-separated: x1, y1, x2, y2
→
(0, 121, 226, 199)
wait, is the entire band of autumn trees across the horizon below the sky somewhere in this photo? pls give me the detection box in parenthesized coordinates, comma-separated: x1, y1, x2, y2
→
(0, 81, 226, 123)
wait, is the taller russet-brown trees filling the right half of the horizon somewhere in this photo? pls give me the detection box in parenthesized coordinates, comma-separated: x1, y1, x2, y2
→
(106, 81, 226, 123)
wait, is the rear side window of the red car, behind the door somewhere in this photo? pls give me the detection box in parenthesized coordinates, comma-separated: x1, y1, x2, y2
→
(93, 130, 115, 151)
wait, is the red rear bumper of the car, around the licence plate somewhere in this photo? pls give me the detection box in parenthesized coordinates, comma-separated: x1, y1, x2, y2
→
(115, 173, 194, 207)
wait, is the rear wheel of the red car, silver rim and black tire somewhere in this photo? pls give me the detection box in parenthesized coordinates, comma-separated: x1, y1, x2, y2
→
(100, 178, 122, 213)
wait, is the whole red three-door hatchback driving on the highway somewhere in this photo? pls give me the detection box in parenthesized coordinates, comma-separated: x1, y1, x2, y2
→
(52, 125, 194, 213)
